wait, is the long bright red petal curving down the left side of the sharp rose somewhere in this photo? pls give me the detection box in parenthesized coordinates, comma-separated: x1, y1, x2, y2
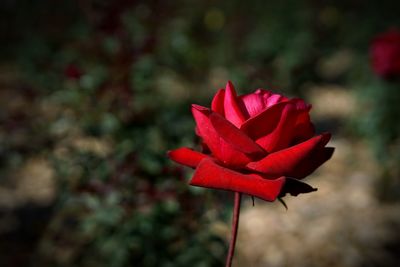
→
(192, 105, 251, 167)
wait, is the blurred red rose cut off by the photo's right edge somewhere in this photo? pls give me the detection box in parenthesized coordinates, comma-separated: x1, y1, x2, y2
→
(370, 30, 400, 78)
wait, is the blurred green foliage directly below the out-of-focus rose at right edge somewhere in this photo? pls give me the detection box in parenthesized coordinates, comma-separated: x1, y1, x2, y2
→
(356, 71, 400, 201)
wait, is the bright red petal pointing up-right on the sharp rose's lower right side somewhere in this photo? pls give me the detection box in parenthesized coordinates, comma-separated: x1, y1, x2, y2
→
(247, 133, 331, 178)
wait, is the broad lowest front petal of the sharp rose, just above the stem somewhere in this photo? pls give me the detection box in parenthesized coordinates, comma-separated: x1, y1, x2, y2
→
(190, 159, 285, 201)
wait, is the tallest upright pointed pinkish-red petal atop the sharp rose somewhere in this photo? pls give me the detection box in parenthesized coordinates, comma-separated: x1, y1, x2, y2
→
(224, 81, 245, 128)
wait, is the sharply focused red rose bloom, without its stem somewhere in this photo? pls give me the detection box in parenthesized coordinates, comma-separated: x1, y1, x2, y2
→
(168, 82, 334, 201)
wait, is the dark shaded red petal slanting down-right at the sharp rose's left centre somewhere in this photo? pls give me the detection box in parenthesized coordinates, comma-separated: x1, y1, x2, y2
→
(210, 112, 265, 155)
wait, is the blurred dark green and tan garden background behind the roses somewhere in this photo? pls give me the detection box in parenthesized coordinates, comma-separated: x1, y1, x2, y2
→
(0, 0, 400, 267)
